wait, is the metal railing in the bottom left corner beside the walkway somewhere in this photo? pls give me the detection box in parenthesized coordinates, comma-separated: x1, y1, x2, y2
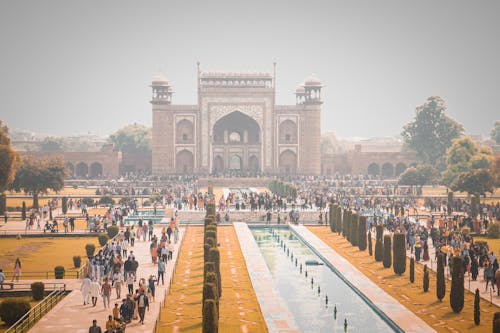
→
(5, 287, 66, 333)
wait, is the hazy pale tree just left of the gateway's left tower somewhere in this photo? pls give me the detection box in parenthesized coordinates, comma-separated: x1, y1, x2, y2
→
(108, 124, 152, 153)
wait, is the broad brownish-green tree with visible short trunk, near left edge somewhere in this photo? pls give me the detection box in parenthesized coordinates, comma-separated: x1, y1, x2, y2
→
(12, 158, 65, 208)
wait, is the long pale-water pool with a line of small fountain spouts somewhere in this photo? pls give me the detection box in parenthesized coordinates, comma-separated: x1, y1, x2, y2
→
(251, 228, 398, 333)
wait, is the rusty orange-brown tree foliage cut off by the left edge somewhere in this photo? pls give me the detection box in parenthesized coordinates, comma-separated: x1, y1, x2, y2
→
(0, 120, 21, 193)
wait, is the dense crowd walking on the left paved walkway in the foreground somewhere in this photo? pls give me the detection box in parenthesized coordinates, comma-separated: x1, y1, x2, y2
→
(81, 219, 179, 333)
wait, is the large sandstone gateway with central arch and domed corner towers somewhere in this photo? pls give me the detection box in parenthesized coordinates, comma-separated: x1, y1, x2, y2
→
(151, 66, 322, 175)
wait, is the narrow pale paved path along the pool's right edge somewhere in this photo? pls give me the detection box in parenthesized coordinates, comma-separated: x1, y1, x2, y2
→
(290, 225, 435, 333)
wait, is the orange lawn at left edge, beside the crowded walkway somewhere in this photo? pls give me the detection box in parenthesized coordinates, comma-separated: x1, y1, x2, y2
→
(0, 237, 99, 280)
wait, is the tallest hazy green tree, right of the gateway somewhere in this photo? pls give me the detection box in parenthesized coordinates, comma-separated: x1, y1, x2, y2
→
(401, 96, 464, 167)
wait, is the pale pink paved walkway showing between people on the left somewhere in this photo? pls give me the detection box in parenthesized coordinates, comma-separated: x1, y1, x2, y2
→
(27, 228, 184, 333)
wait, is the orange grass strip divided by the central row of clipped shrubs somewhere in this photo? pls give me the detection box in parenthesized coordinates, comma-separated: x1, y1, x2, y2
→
(158, 226, 267, 333)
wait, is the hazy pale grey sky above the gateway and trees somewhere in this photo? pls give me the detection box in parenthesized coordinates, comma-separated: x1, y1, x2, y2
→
(0, 0, 500, 137)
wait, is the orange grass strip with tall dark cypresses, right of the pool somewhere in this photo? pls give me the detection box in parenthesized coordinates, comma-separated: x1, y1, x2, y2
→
(308, 227, 500, 332)
